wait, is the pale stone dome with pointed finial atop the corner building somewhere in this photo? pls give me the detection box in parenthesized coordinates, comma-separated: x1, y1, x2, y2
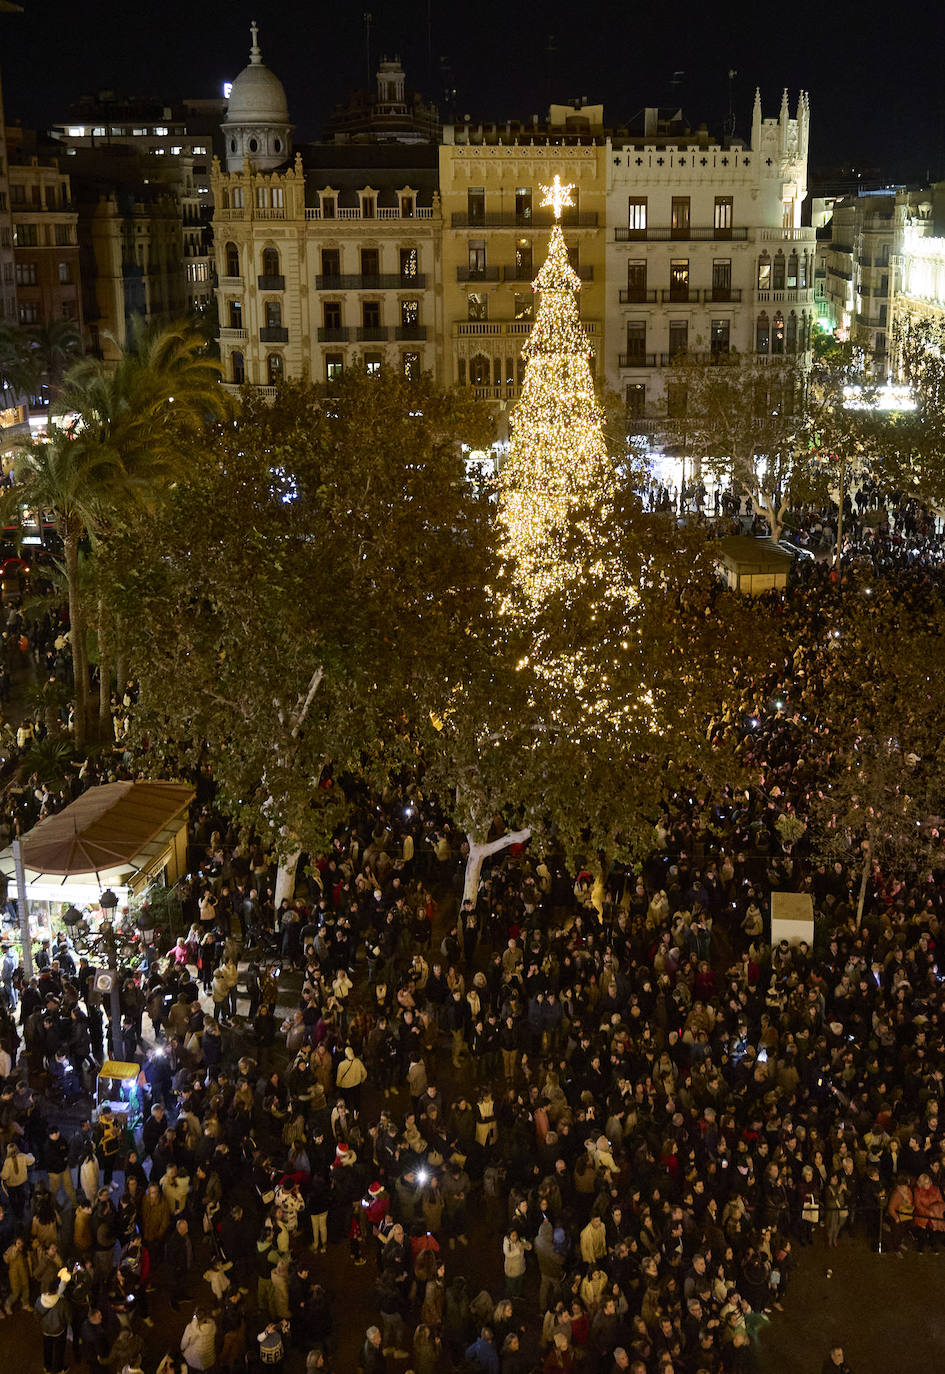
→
(221, 19, 293, 172)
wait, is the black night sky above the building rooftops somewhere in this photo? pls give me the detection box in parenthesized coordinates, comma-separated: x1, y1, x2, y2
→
(0, 0, 945, 180)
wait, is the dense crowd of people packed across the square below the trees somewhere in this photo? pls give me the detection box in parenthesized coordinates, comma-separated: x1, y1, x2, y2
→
(0, 497, 945, 1374)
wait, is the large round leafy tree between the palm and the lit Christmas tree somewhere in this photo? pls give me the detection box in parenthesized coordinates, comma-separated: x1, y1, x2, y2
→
(114, 370, 492, 897)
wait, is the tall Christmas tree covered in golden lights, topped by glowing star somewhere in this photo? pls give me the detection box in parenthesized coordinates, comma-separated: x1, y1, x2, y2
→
(499, 176, 615, 609)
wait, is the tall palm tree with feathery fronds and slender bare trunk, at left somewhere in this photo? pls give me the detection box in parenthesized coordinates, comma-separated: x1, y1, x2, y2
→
(10, 323, 229, 749)
